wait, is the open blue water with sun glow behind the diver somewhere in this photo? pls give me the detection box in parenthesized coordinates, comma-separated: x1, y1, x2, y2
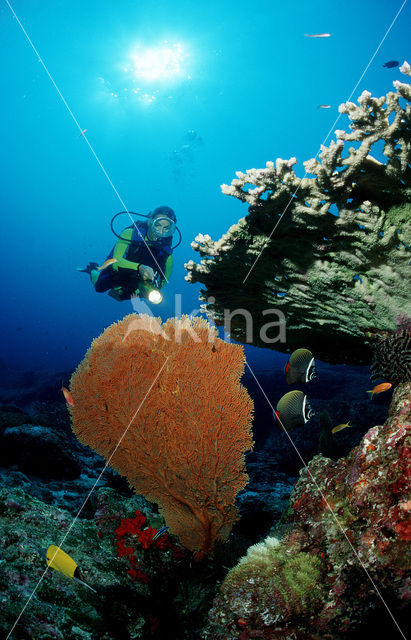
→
(0, 0, 411, 370)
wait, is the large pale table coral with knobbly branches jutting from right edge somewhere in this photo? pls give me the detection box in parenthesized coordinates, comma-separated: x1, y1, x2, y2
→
(185, 63, 411, 370)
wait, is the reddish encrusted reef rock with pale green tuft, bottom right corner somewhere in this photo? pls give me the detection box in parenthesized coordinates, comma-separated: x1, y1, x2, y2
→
(203, 383, 411, 640)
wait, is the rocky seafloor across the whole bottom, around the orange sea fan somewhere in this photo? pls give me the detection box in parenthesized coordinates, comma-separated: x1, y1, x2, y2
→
(0, 363, 411, 640)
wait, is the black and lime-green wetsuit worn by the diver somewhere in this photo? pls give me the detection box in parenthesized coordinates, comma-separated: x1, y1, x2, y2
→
(90, 222, 173, 300)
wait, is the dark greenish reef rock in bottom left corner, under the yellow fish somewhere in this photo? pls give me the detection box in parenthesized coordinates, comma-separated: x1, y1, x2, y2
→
(0, 488, 217, 640)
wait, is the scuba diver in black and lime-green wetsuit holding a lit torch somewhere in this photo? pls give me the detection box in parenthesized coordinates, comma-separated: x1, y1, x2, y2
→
(78, 206, 181, 304)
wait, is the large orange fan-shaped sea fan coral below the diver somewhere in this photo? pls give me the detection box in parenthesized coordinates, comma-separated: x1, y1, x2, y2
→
(69, 314, 253, 559)
